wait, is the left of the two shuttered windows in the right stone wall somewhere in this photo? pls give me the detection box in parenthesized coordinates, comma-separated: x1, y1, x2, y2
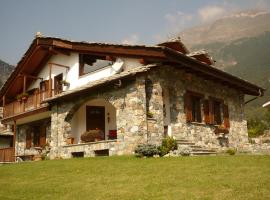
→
(184, 91, 203, 123)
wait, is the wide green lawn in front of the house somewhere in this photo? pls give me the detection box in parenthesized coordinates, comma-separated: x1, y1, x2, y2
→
(0, 155, 270, 200)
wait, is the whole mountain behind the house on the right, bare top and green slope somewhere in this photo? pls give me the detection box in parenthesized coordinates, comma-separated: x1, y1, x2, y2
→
(180, 11, 270, 119)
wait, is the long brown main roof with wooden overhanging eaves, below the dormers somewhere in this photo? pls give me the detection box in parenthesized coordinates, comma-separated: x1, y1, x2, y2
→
(0, 37, 264, 101)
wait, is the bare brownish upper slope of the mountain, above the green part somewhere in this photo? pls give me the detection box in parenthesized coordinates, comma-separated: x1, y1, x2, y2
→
(180, 10, 270, 46)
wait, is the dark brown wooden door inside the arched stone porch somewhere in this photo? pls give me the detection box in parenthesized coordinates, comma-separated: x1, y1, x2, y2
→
(86, 106, 105, 139)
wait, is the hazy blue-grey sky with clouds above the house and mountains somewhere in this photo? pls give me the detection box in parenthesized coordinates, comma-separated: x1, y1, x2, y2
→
(0, 0, 270, 65)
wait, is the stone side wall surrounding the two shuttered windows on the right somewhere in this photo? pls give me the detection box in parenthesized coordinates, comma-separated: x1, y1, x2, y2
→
(149, 66, 248, 148)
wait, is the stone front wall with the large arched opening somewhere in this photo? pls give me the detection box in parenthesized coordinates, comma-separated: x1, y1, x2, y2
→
(50, 76, 147, 158)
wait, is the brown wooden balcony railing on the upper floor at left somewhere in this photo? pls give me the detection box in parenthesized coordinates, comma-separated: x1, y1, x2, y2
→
(3, 91, 54, 118)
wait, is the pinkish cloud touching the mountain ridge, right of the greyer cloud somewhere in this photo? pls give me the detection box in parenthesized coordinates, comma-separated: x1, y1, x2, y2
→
(198, 5, 227, 22)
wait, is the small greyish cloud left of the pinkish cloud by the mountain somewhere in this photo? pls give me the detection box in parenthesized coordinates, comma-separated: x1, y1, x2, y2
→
(164, 11, 193, 31)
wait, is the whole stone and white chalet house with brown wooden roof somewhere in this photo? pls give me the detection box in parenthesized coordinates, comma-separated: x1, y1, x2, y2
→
(0, 36, 263, 159)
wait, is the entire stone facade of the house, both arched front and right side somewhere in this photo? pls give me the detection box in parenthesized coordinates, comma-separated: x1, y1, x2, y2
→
(14, 66, 253, 159)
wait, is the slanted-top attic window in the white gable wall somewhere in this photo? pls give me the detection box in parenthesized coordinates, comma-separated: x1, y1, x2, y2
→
(79, 54, 113, 76)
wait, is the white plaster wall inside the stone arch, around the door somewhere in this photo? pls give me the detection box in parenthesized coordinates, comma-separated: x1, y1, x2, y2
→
(71, 99, 117, 143)
